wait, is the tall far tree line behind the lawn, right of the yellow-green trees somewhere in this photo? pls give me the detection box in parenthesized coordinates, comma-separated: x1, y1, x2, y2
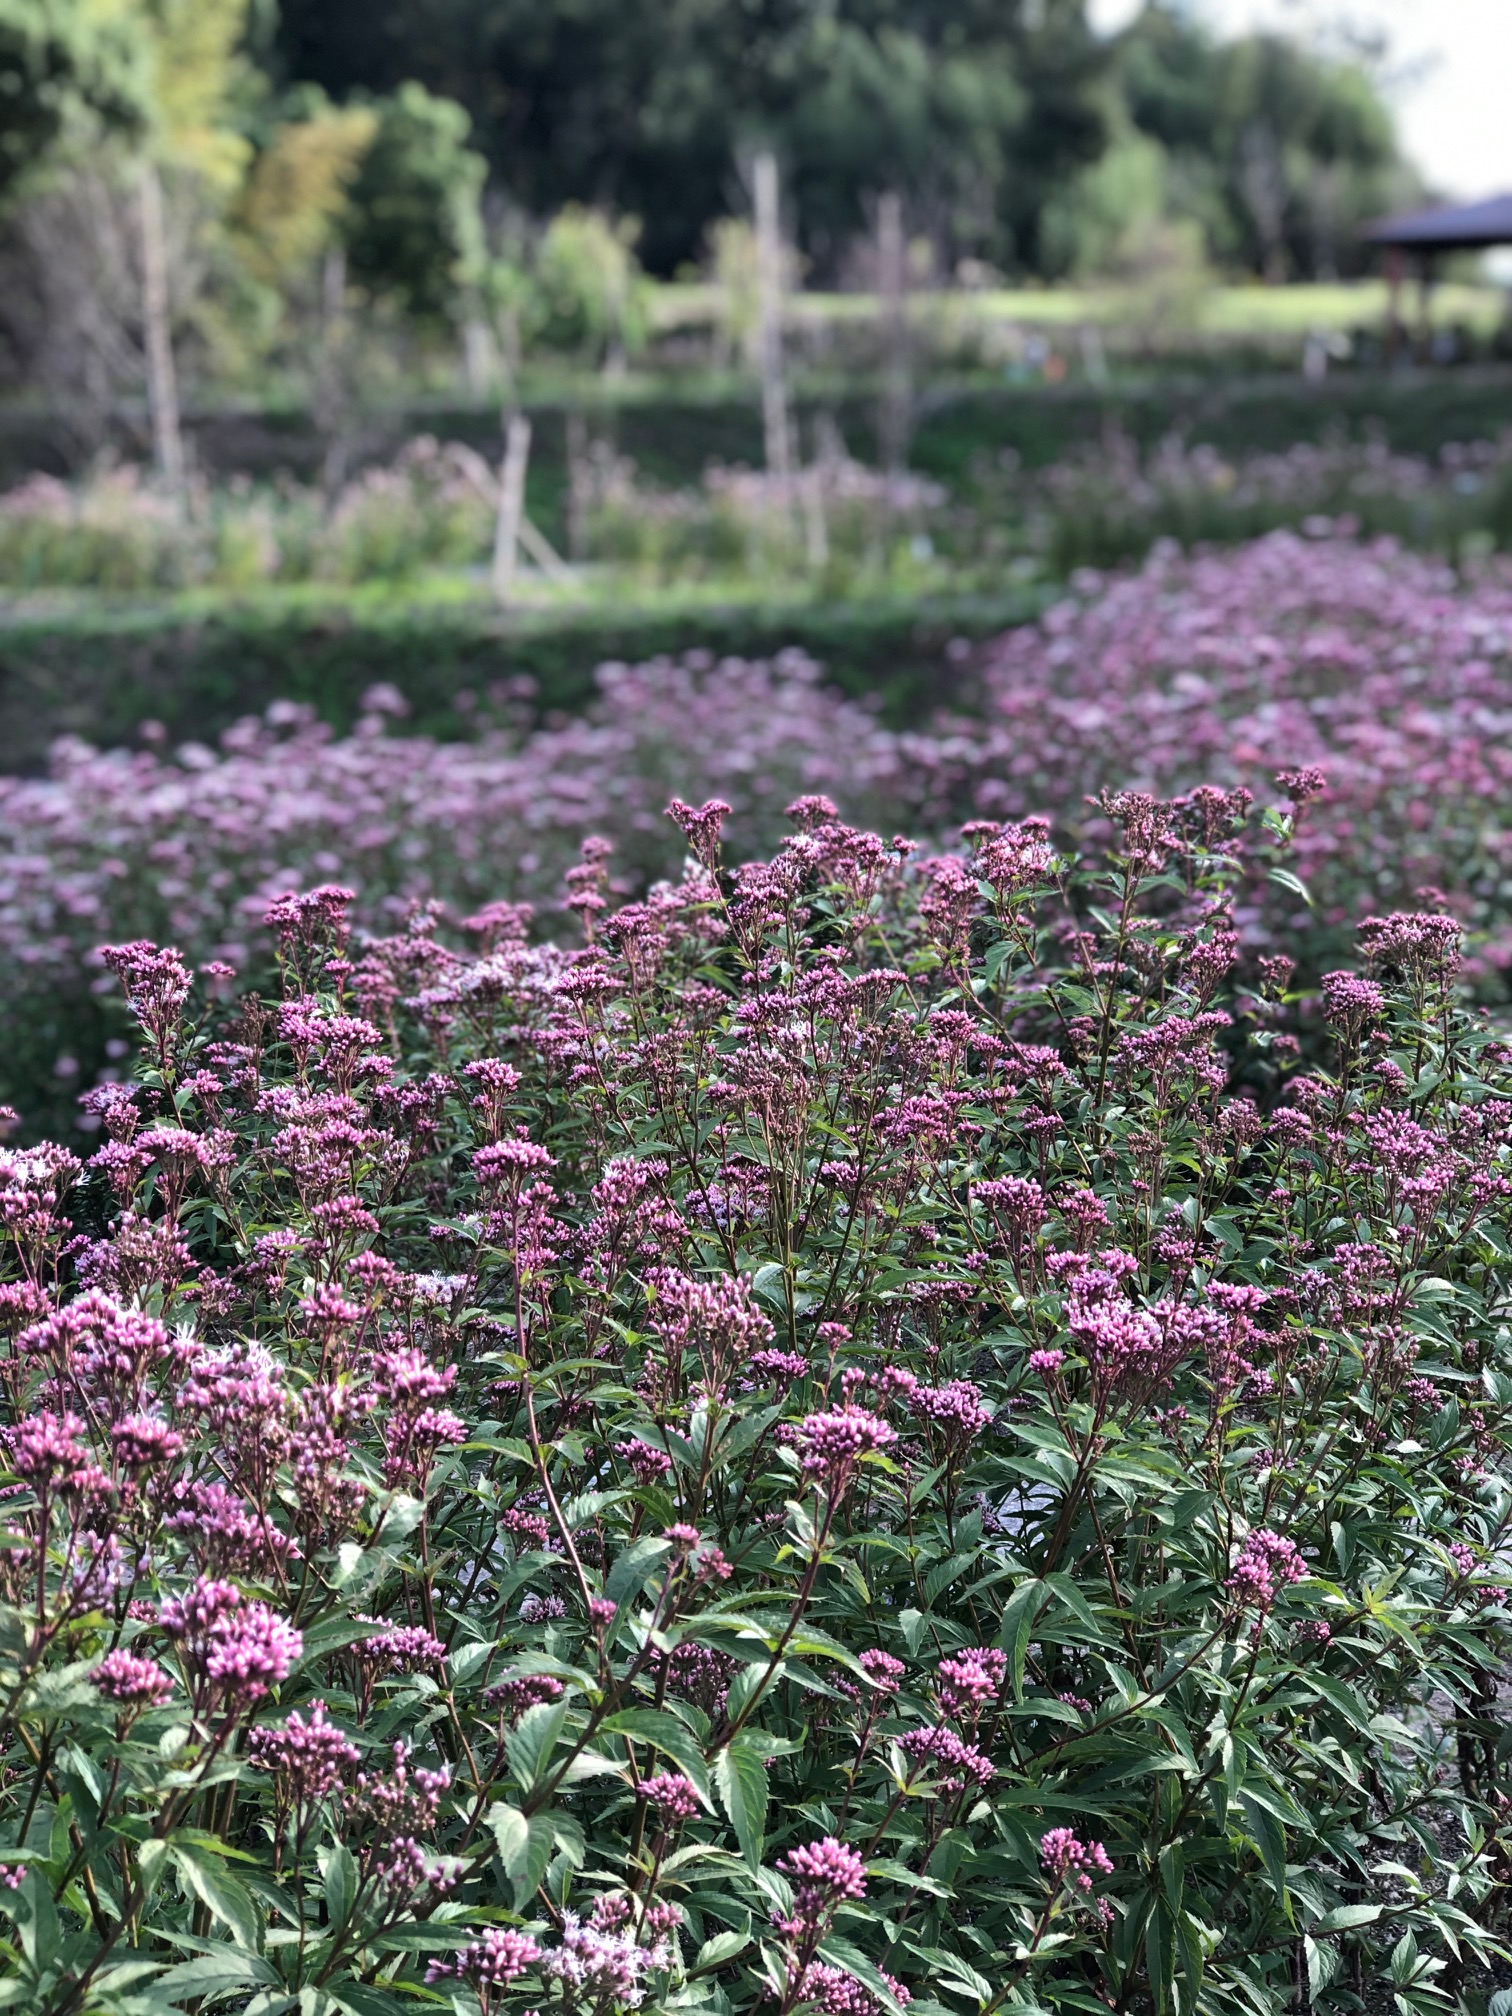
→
(270, 0, 1399, 276)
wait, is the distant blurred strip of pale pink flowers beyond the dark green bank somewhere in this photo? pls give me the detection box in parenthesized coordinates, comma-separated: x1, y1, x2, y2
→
(0, 427, 1512, 595)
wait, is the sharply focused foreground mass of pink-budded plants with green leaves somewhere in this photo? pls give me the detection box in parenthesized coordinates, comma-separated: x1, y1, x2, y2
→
(0, 788, 1512, 2016)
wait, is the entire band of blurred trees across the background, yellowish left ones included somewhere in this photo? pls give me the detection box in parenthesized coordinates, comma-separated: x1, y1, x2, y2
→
(0, 0, 1419, 427)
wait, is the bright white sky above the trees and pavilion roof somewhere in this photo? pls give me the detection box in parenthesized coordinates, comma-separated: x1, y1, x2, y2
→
(1089, 0, 1512, 198)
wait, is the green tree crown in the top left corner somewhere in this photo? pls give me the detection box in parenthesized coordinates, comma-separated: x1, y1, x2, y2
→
(0, 0, 149, 206)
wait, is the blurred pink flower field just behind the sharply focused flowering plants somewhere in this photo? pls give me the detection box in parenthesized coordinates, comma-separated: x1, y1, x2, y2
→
(0, 534, 1512, 1117)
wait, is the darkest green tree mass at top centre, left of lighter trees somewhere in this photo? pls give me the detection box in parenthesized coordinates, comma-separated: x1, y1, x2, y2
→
(280, 0, 1105, 272)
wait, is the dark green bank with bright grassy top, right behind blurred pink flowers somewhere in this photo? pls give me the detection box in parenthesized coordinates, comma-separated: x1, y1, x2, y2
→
(0, 587, 1046, 772)
